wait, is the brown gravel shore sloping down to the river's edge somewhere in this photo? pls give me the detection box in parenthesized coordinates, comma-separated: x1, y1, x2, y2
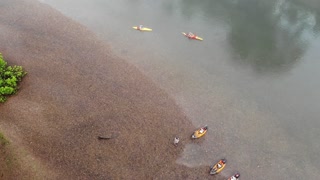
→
(0, 0, 221, 179)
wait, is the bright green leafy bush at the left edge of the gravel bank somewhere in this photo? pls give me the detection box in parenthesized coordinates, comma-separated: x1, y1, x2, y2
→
(0, 53, 27, 103)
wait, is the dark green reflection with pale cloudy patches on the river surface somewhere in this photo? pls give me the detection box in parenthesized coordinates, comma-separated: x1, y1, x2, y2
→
(181, 0, 320, 73)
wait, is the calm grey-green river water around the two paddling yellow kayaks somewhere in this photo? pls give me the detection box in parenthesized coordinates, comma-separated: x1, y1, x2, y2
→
(41, 0, 320, 180)
